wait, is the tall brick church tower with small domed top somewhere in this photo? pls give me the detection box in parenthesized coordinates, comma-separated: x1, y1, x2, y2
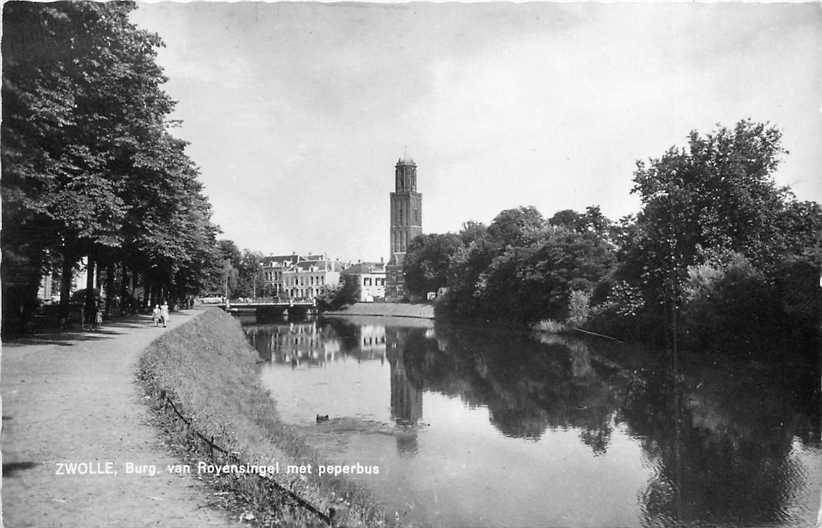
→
(385, 156, 422, 301)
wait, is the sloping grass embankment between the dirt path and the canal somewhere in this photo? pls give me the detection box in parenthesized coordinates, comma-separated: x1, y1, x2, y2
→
(140, 309, 386, 527)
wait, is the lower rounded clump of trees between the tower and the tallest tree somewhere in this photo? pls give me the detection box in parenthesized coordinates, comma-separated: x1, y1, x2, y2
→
(440, 206, 614, 324)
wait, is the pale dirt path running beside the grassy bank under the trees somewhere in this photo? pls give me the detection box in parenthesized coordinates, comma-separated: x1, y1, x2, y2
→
(0, 311, 236, 528)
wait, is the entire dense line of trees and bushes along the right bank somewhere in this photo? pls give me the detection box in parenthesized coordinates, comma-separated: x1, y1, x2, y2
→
(405, 120, 822, 345)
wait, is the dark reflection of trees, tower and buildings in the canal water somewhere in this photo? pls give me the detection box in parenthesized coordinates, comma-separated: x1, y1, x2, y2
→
(243, 320, 820, 526)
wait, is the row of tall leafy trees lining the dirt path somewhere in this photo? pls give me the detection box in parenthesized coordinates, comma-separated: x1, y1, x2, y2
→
(2, 2, 220, 330)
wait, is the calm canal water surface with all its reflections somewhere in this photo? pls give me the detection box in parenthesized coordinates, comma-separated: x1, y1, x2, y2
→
(244, 318, 822, 528)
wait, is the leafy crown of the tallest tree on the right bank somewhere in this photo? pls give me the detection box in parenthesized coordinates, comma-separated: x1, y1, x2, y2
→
(625, 121, 785, 299)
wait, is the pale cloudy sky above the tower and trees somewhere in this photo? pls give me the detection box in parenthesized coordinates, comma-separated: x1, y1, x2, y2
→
(134, 3, 822, 259)
